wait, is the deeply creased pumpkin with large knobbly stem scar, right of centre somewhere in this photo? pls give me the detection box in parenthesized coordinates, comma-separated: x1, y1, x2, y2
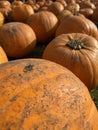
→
(42, 33, 98, 90)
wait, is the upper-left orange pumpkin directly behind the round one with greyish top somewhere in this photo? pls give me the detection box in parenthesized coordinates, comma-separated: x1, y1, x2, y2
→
(11, 4, 34, 23)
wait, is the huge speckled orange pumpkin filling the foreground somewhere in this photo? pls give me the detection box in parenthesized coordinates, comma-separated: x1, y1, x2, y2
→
(0, 59, 98, 130)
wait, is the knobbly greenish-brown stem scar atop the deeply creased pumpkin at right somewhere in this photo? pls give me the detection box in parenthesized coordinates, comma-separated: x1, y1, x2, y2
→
(66, 39, 84, 50)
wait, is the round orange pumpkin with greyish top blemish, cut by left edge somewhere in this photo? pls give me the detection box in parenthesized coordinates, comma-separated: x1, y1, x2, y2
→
(0, 22, 36, 58)
